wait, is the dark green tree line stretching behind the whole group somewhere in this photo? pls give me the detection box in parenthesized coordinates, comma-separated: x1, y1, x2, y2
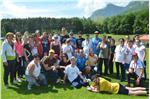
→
(1, 9, 149, 36)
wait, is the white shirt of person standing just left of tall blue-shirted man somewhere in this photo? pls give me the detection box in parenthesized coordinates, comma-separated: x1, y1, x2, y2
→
(82, 40, 92, 55)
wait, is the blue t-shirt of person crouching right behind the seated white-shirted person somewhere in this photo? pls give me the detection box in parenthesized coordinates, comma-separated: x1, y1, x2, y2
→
(76, 55, 86, 71)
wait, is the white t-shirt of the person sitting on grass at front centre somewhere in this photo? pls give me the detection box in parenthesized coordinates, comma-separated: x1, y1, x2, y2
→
(64, 64, 81, 82)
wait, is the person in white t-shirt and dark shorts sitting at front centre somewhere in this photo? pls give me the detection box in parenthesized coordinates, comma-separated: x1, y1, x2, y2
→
(64, 56, 89, 88)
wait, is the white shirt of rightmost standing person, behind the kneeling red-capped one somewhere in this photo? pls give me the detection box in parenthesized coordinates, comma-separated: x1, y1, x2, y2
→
(135, 45, 145, 61)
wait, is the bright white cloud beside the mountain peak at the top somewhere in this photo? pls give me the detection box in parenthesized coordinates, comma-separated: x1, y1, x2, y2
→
(77, 0, 133, 17)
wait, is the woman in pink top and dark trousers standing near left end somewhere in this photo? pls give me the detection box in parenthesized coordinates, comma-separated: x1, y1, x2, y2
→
(15, 32, 24, 82)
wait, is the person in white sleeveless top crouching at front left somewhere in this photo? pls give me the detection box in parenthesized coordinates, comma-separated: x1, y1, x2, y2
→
(25, 54, 47, 90)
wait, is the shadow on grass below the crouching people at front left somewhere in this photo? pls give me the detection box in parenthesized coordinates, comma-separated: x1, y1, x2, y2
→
(9, 81, 73, 95)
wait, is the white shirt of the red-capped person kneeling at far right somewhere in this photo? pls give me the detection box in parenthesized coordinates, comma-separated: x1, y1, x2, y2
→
(130, 60, 144, 77)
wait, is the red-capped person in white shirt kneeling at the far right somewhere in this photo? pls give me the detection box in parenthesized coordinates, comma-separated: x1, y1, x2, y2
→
(127, 53, 144, 86)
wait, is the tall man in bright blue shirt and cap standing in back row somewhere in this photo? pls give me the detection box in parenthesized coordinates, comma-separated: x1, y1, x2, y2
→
(92, 31, 102, 55)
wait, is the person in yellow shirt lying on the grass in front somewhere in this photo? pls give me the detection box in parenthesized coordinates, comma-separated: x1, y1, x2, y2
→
(87, 76, 149, 95)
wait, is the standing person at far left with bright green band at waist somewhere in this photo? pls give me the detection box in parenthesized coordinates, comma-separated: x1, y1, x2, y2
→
(1, 32, 16, 88)
